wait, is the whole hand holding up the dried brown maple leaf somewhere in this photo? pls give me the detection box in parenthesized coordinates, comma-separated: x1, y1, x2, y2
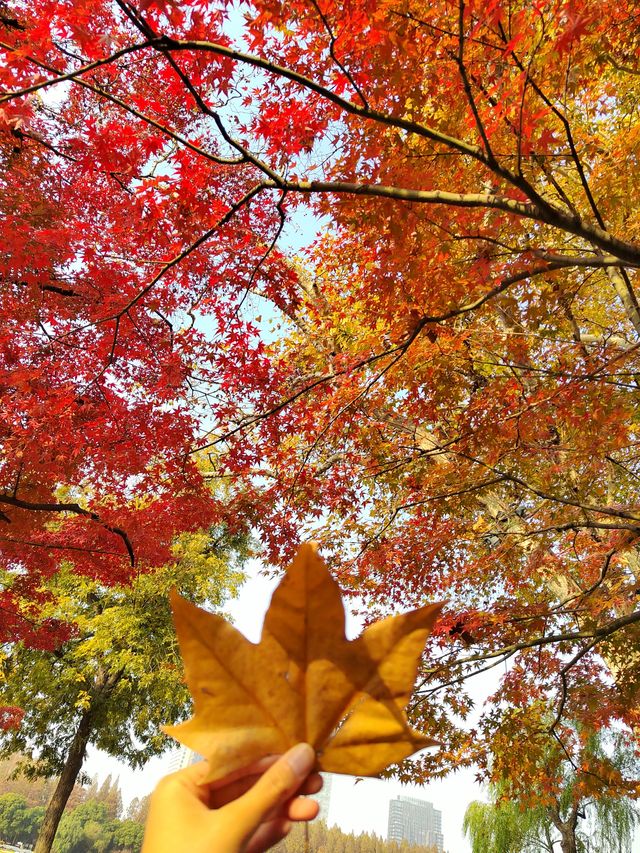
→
(142, 743, 322, 853)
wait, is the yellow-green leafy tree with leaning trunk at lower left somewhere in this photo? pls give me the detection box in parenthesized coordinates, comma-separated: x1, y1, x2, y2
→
(0, 532, 244, 853)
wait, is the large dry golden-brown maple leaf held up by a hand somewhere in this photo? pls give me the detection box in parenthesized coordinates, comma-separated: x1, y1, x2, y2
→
(164, 544, 442, 781)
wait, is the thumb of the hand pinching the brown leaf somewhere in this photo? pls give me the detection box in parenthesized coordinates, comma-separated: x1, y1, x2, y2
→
(232, 743, 316, 838)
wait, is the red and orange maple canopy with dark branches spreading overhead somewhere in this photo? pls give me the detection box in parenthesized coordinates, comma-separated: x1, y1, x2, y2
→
(0, 0, 640, 792)
